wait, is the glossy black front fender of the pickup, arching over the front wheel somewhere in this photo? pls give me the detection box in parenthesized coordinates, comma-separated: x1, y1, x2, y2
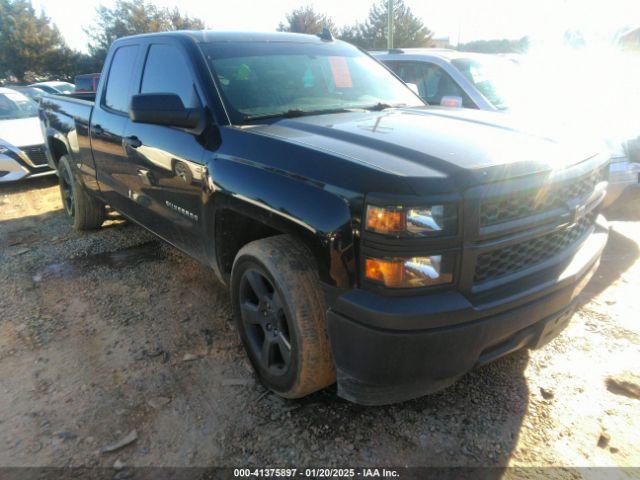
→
(205, 158, 356, 288)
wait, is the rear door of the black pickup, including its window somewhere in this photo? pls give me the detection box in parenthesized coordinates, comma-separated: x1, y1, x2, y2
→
(90, 44, 141, 215)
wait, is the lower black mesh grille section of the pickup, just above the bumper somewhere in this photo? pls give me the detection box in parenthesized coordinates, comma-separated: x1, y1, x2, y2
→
(473, 212, 597, 283)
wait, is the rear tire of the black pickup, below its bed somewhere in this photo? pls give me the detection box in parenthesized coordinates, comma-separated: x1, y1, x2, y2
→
(58, 156, 105, 230)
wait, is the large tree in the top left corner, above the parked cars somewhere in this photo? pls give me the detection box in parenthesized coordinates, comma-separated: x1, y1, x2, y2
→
(0, 0, 74, 82)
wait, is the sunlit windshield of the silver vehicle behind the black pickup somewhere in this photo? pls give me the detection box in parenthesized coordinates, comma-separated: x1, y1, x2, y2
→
(451, 58, 520, 110)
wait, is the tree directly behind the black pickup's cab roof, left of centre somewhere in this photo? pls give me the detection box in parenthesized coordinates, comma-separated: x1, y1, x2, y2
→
(85, 0, 205, 64)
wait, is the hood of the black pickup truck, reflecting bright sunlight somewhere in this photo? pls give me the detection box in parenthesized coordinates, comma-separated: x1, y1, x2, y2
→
(249, 107, 600, 188)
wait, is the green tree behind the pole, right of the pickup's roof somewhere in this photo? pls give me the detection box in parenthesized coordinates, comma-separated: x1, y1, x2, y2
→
(340, 0, 433, 49)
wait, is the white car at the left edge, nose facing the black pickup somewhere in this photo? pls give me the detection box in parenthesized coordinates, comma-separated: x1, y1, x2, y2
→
(0, 88, 55, 183)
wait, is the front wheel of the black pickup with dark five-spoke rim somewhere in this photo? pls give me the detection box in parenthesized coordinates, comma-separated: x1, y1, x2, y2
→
(231, 235, 336, 398)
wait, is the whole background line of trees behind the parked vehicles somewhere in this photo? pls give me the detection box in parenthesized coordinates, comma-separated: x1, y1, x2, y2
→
(0, 0, 521, 82)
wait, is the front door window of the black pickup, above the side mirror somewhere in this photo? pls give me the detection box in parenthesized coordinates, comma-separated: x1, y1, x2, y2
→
(140, 44, 199, 108)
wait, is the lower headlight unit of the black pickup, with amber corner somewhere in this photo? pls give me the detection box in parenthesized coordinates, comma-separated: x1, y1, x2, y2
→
(365, 255, 454, 288)
